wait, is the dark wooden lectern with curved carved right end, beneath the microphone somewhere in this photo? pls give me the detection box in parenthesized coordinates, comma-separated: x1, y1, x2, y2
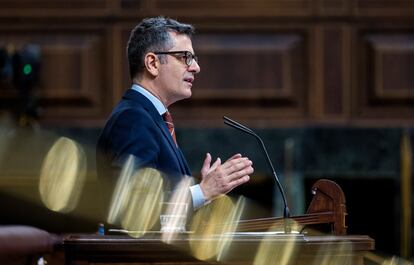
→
(64, 180, 374, 265)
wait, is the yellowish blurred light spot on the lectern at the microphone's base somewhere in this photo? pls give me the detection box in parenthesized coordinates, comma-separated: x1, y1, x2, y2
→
(253, 219, 300, 265)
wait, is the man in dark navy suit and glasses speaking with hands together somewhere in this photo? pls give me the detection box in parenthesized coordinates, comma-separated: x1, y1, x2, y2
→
(97, 17, 253, 213)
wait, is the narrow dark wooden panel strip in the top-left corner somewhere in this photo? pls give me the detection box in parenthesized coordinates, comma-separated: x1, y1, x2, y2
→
(0, 0, 114, 18)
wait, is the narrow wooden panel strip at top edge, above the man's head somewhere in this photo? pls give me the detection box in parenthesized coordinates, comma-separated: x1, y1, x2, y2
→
(153, 0, 313, 17)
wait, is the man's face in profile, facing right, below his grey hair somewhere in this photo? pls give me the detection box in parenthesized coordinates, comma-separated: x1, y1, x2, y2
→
(157, 32, 200, 107)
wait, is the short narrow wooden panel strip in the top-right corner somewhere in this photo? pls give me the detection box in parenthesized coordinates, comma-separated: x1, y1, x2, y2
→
(354, 0, 414, 17)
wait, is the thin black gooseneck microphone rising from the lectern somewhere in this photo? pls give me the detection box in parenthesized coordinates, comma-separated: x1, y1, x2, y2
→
(223, 116, 290, 219)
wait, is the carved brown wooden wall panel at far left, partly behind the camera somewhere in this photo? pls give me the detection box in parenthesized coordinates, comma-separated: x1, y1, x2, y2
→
(0, 28, 106, 120)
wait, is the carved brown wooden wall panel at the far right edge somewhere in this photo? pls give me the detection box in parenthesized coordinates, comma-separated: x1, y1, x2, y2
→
(357, 29, 414, 118)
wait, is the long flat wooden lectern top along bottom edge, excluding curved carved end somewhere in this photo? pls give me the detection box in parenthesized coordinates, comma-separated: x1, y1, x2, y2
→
(64, 233, 375, 264)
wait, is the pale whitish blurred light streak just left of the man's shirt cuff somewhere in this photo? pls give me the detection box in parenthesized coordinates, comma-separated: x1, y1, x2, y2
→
(160, 176, 194, 243)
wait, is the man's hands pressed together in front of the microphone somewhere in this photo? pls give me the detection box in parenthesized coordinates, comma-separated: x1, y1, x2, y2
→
(200, 153, 254, 200)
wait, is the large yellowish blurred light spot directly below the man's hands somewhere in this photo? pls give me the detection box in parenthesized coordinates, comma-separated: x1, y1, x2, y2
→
(190, 196, 245, 260)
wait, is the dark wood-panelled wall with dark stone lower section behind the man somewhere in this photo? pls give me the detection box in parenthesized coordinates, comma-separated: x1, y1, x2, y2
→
(0, 0, 414, 260)
